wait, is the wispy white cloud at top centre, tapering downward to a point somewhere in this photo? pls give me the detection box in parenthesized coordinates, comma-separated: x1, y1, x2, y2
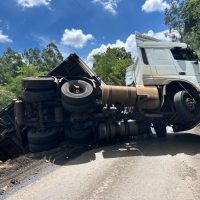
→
(92, 0, 120, 15)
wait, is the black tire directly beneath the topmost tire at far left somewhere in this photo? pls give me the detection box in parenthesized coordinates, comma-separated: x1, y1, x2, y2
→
(22, 90, 57, 103)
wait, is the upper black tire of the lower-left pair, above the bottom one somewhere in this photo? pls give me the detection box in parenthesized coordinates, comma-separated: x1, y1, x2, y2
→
(27, 129, 60, 145)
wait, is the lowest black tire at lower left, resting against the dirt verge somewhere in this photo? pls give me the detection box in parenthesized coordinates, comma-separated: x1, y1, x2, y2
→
(28, 140, 59, 153)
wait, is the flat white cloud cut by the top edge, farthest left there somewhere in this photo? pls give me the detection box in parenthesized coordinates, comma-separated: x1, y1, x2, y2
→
(17, 0, 51, 8)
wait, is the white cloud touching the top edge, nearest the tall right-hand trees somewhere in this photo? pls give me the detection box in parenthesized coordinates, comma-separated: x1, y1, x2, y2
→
(142, 0, 169, 13)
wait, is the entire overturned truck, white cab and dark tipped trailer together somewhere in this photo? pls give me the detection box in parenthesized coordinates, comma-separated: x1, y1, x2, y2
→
(0, 34, 200, 160)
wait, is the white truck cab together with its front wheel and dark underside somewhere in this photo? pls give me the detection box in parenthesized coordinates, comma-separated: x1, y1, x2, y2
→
(123, 34, 200, 135)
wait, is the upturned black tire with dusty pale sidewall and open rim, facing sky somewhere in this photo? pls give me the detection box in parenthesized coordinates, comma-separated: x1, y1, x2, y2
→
(61, 80, 94, 105)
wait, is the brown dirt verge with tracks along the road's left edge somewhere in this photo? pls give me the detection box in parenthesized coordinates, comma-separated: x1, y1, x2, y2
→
(0, 144, 86, 195)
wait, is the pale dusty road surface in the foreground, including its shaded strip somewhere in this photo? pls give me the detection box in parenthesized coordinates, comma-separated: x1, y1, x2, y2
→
(2, 132, 200, 200)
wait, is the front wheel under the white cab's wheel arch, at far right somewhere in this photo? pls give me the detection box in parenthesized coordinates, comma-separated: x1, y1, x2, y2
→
(174, 91, 198, 122)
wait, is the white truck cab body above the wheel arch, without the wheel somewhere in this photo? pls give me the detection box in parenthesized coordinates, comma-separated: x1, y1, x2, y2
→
(126, 34, 200, 90)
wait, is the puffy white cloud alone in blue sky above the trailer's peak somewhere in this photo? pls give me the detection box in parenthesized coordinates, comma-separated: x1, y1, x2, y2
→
(61, 29, 94, 48)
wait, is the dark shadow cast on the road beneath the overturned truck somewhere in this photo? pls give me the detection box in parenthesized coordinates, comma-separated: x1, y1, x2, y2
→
(54, 133, 200, 165)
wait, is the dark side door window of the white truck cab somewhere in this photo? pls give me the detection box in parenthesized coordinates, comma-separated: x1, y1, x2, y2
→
(171, 48, 196, 60)
